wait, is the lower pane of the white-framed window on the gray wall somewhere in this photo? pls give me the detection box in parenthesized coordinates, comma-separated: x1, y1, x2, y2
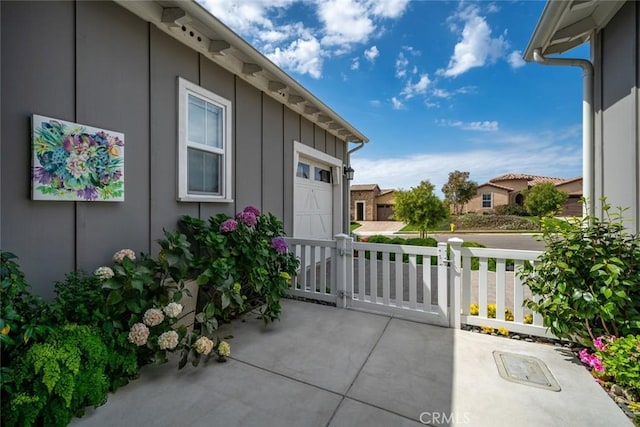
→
(187, 148, 222, 195)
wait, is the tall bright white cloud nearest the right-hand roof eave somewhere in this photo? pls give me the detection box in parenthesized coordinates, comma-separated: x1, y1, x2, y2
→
(438, 6, 508, 77)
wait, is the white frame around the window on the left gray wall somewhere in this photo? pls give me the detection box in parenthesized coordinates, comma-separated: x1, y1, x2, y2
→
(177, 77, 233, 203)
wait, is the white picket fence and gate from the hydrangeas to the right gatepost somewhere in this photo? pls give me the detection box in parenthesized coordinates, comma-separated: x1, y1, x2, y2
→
(288, 235, 449, 326)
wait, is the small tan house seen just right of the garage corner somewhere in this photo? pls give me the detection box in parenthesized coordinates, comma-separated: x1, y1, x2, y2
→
(351, 184, 396, 221)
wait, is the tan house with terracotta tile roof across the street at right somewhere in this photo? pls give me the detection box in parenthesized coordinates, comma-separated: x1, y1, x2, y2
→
(462, 173, 582, 216)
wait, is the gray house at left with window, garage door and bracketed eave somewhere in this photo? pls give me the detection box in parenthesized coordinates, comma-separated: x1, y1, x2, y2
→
(0, 1, 368, 297)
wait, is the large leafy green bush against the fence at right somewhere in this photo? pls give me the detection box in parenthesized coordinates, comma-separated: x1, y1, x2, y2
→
(521, 200, 640, 342)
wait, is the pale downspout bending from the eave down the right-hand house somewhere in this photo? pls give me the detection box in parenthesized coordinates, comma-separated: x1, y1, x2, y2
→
(533, 49, 596, 216)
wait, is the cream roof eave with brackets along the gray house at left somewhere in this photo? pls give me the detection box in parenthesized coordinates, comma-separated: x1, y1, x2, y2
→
(114, 0, 369, 143)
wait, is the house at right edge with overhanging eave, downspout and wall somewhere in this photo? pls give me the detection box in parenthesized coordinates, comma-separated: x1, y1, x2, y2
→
(524, 0, 640, 233)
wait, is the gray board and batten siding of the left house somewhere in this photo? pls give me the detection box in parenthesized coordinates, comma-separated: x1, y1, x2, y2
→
(0, 1, 346, 297)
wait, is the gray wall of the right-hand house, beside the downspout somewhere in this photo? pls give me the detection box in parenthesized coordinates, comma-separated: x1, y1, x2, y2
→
(592, 1, 640, 233)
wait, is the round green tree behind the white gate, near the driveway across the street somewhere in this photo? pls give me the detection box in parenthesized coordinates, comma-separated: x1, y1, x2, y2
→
(394, 181, 448, 237)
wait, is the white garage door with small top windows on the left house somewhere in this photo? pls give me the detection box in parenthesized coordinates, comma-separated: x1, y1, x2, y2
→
(293, 156, 333, 239)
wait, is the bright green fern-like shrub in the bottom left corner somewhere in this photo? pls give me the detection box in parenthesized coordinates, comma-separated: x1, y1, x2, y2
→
(2, 325, 109, 426)
